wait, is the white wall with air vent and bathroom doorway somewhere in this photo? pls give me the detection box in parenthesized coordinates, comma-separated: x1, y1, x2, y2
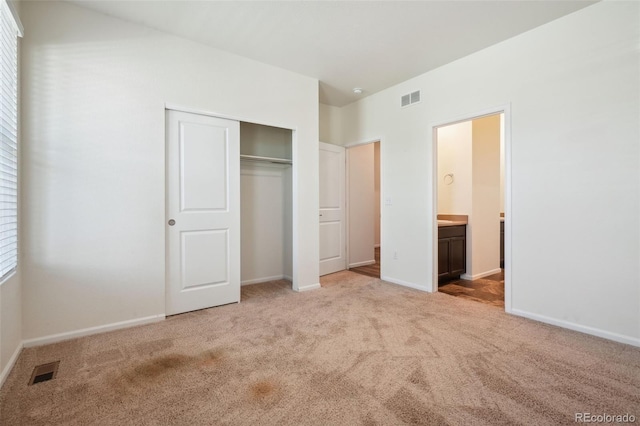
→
(342, 1, 640, 344)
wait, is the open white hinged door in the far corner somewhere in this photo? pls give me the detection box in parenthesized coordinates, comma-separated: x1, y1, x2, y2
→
(320, 142, 347, 275)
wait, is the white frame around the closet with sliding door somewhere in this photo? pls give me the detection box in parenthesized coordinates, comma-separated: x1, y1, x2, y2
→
(162, 102, 302, 296)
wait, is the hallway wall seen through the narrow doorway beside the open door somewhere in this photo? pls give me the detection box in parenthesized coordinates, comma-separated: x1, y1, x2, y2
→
(347, 143, 375, 268)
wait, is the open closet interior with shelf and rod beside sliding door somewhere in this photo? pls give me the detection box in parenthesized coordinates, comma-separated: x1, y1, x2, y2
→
(240, 122, 293, 285)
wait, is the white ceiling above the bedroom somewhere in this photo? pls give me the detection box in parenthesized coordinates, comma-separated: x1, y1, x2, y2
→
(67, 0, 594, 106)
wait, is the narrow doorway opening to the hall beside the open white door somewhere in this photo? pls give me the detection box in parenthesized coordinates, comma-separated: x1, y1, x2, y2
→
(347, 141, 381, 278)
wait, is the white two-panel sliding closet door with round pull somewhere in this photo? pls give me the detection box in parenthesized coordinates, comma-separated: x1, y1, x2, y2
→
(166, 110, 240, 315)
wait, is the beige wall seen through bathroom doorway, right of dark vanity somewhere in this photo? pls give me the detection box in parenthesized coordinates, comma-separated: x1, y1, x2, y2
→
(463, 115, 500, 280)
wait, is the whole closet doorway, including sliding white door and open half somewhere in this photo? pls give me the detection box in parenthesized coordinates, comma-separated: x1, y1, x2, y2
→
(165, 110, 293, 315)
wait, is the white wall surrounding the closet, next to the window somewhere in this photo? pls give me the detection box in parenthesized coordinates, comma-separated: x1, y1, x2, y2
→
(22, 2, 319, 339)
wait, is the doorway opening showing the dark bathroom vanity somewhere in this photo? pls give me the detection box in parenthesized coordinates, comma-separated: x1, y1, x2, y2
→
(433, 108, 510, 311)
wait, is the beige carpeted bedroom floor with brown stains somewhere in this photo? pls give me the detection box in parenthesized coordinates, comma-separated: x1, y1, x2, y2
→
(0, 272, 640, 425)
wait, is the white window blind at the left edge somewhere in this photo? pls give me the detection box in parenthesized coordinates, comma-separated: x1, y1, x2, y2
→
(0, 0, 19, 278)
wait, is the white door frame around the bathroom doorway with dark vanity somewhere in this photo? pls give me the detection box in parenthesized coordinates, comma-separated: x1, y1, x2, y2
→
(428, 104, 513, 313)
